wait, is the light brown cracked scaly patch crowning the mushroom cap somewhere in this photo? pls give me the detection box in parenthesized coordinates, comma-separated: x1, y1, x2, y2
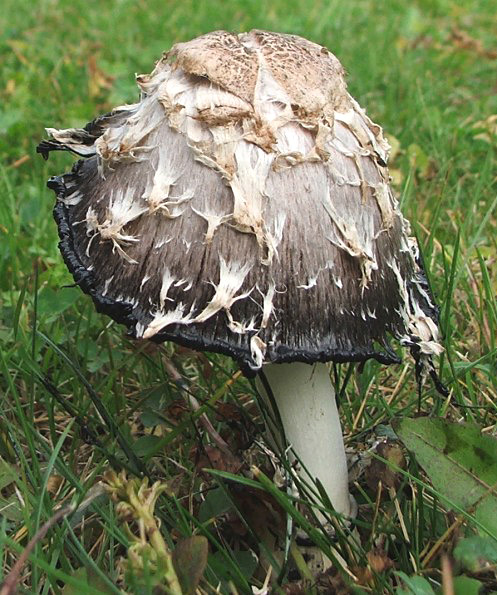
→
(166, 30, 350, 115)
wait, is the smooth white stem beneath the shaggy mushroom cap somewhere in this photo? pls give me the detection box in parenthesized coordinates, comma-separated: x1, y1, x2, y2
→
(257, 362, 351, 516)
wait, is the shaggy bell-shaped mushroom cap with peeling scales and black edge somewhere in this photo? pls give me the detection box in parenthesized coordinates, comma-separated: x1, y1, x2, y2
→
(38, 30, 441, 372)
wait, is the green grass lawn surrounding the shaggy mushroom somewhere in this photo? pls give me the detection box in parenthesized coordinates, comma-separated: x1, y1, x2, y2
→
(0, 0, 497, 594)
